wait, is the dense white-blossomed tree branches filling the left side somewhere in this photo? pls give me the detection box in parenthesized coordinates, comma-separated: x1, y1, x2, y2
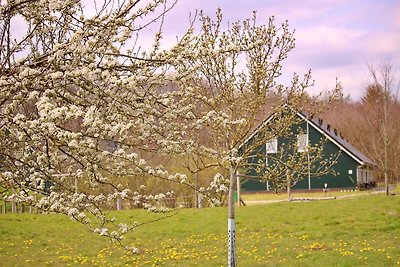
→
(0, 0, 203, 251)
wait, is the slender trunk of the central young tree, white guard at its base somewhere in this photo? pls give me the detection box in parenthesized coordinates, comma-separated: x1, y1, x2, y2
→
(228, 166, 237, 267)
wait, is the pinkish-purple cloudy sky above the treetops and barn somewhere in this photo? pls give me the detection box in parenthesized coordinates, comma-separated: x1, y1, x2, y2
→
(157, 0, 400, 100)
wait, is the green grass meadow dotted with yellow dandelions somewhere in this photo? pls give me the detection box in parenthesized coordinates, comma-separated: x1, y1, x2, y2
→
(0, 195, 400, 266)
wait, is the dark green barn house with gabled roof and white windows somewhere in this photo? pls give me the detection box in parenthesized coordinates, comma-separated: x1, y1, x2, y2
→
(239, 107, 376, 193)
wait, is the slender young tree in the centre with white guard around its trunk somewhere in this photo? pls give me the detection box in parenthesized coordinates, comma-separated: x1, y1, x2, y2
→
(172, 10, 338, 266)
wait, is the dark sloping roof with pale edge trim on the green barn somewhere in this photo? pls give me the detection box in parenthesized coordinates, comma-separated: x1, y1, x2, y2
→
(243, 105, 377, 166)
